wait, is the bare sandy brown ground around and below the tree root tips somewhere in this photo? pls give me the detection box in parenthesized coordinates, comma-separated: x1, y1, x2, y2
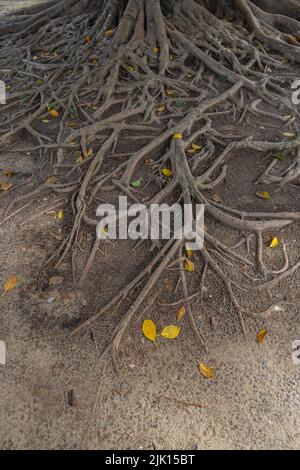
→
(0, 2, 300, 450)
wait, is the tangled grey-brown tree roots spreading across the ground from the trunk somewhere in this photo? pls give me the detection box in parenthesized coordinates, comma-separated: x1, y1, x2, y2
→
(0, 0, 300, 368)
